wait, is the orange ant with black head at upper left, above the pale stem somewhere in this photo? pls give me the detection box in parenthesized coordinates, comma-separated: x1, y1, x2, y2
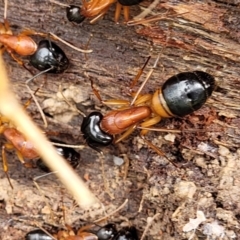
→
(0, 0, 92, 73)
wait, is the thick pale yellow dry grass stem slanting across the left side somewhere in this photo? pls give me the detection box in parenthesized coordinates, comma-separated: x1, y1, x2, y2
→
(0, 56, 97, 207)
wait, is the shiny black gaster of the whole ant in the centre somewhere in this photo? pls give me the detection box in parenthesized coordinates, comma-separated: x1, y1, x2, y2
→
(162, 71, 215, 117)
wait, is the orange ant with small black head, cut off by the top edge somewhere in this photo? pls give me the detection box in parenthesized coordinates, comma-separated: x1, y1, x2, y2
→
(50, 0, 143, 24)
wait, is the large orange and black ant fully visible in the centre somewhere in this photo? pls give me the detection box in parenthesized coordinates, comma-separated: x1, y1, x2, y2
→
(81, 55, 215, 156)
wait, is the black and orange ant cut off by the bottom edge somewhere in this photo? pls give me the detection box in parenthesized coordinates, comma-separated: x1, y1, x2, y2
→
(25, 223, 138, 240)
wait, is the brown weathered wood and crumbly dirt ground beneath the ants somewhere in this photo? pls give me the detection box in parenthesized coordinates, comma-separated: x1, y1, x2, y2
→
(0, 0, 240, 240)
